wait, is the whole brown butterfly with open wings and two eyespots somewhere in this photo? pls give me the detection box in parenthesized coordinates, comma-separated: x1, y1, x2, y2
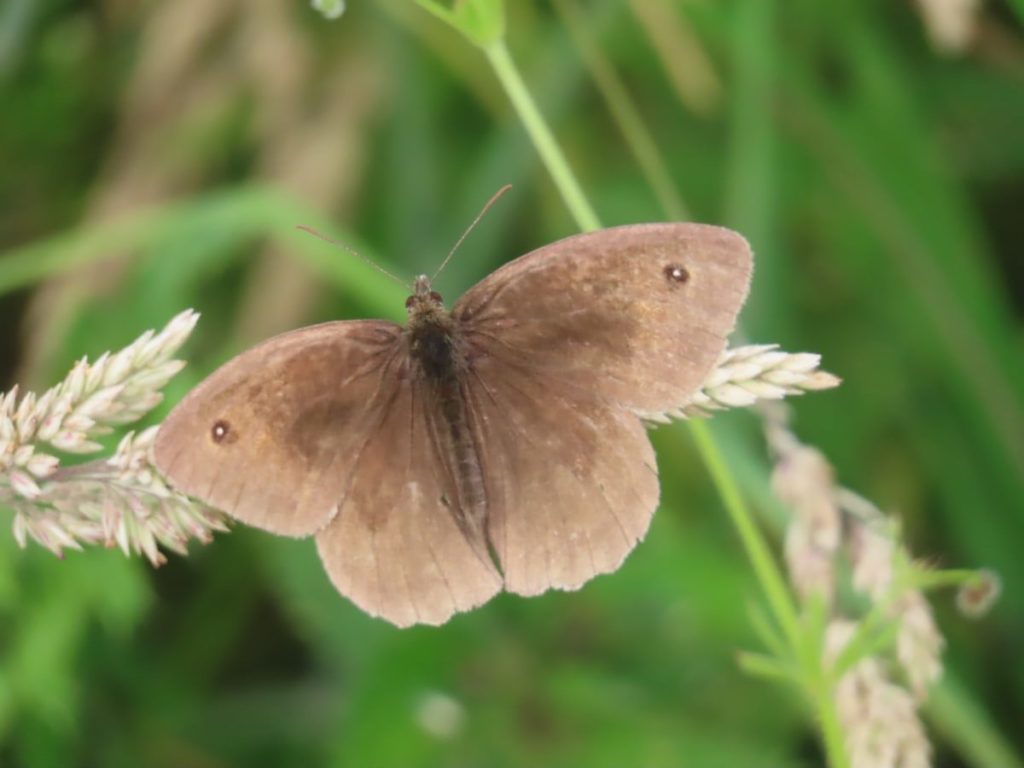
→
(156, 224, 752, 627)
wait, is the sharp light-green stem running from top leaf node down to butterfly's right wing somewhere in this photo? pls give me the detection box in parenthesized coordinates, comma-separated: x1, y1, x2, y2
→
(483, 40, 601, 231)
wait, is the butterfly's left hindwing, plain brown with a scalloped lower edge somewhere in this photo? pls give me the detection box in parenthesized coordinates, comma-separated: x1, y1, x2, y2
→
(316, 379, 502, 627)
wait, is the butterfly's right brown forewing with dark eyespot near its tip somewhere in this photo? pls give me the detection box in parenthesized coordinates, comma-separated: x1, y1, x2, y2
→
(453, 224, 751, 414)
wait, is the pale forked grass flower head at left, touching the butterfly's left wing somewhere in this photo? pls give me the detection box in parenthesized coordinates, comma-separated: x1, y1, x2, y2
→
(0, 310, 225, 565)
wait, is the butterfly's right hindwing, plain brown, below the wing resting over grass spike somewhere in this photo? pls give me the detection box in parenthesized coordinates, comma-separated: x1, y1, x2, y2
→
(468, 358, 658, 595)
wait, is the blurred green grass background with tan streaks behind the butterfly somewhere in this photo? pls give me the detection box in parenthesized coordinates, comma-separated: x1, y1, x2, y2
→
(0, 0, 1024, 768)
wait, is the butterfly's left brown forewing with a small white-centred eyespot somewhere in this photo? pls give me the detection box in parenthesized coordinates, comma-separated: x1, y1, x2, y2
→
(155, 321, 401, 536)
